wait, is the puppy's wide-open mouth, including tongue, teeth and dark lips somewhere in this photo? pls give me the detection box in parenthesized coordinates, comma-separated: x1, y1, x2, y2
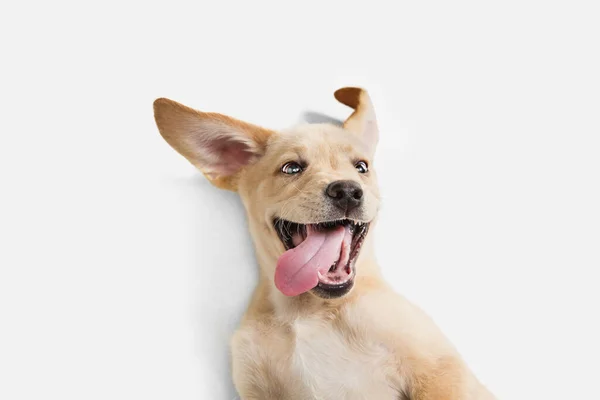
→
(274, 219, 369, 298)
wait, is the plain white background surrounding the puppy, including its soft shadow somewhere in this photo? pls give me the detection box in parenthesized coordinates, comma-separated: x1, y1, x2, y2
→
(0, 0, 600, 400)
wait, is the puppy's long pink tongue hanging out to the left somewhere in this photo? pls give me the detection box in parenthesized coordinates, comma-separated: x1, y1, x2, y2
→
(275, 225, 350, 296)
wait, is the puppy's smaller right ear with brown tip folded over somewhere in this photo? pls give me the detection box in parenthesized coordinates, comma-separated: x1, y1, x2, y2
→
(334, 87, 379, 151)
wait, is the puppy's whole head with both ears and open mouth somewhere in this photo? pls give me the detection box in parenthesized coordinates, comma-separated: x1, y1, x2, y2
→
(154, 88, 379, 298)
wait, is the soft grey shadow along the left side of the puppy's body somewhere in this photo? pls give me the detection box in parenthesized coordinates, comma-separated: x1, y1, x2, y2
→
(180, 173, 258, 400)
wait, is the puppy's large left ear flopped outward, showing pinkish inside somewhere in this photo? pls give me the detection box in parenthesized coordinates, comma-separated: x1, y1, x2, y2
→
(154, 98, 273, 190)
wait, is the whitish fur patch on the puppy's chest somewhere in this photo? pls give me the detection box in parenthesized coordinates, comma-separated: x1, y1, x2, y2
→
(292, 319, 398, 400)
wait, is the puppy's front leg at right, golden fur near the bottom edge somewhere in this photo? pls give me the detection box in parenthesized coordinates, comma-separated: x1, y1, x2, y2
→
(348, 289, 494, 400)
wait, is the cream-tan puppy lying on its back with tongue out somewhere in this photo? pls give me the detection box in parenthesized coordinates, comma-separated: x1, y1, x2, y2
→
(154, 87, 495, 400)
